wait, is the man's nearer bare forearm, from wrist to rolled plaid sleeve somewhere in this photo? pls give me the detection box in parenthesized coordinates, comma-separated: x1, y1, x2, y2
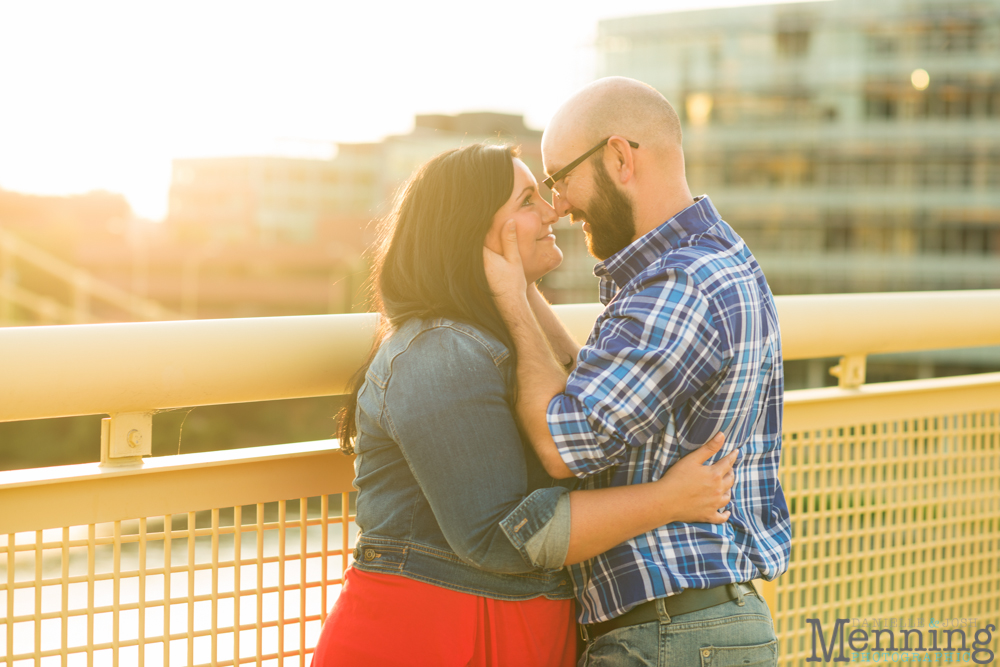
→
(498, 295, 573, 479)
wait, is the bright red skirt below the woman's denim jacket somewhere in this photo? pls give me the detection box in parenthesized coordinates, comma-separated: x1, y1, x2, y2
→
(312, 567, 576, 667)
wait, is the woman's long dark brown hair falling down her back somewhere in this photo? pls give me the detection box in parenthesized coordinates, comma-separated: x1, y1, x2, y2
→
(337, 144, 517, 454)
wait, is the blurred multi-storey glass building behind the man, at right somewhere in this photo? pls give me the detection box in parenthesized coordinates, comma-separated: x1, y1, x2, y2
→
(558, 0, 1000, 300)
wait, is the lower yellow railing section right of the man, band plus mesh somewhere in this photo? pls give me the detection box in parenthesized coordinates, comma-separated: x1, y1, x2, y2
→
(780, 373, 1000, 665)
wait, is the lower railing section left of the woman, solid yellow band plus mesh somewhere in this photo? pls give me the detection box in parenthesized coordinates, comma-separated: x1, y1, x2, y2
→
(0, 441, 356, 666)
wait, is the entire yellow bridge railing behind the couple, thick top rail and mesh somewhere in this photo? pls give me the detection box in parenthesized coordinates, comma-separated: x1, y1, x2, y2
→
(0, 291, 1000, 665)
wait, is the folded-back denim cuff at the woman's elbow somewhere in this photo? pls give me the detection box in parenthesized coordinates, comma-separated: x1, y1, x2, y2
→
(500, 486, 570, 572)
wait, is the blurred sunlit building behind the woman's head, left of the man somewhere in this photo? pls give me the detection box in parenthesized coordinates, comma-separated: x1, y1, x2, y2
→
(167, 113, 541, 254)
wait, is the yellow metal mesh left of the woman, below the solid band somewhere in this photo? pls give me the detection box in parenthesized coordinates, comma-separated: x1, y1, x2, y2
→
(0, 493, 357, 667)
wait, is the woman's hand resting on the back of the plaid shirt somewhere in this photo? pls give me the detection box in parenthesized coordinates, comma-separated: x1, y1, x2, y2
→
(654, 433, 739, 524)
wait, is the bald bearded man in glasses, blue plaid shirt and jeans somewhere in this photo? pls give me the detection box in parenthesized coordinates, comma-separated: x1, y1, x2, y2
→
(487, 77, 791, 667)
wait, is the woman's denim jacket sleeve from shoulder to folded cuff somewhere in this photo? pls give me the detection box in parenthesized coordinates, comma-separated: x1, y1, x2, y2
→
(381, 325, 568, 573)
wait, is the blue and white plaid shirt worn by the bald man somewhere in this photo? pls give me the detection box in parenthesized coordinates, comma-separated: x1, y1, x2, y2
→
(548, 197, 791, 623)
